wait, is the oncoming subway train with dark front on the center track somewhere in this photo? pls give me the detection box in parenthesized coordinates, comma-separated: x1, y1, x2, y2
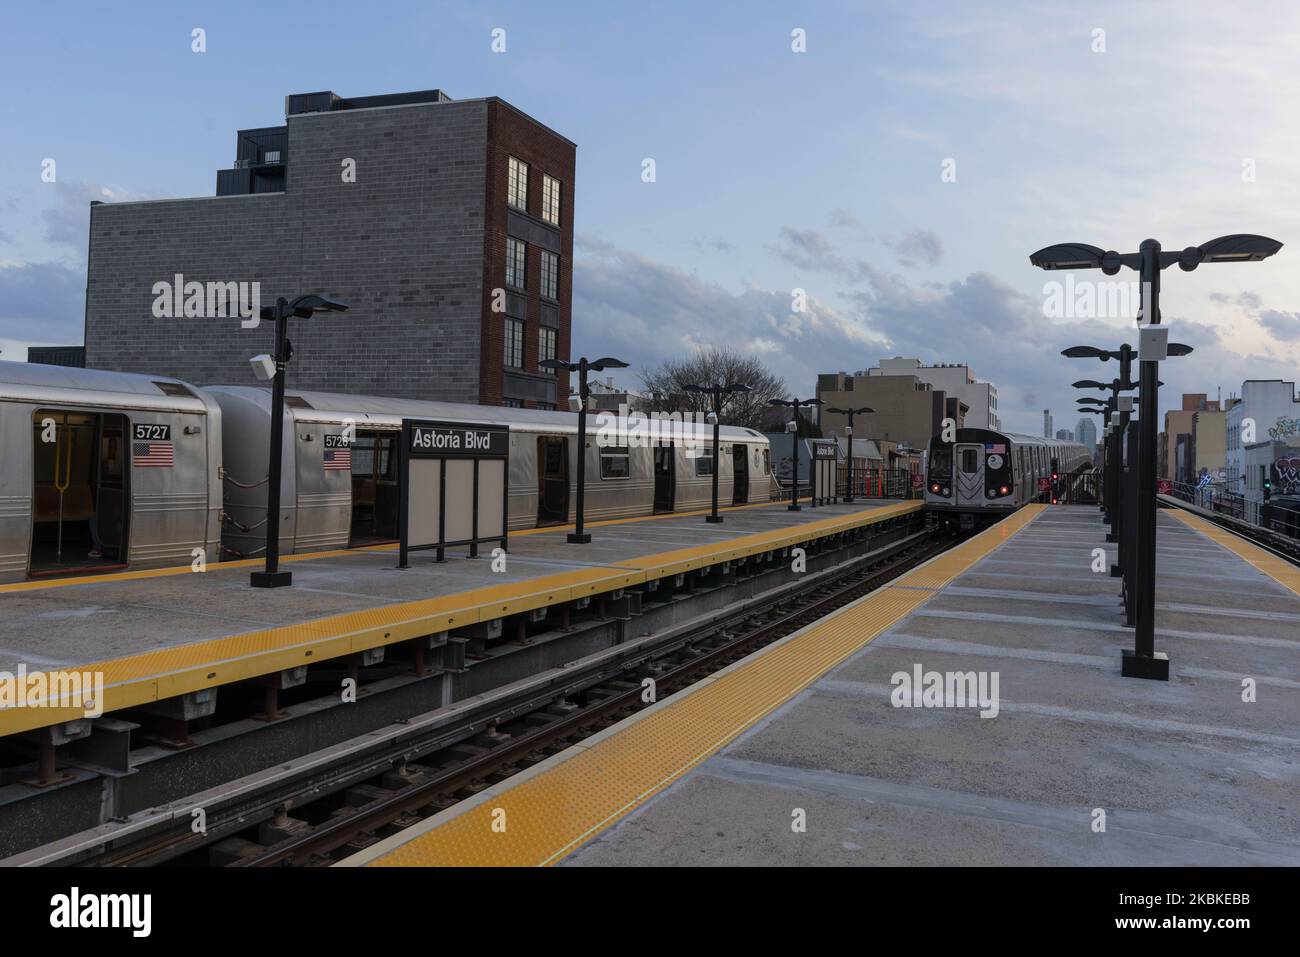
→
(926, 429, 1093, 528)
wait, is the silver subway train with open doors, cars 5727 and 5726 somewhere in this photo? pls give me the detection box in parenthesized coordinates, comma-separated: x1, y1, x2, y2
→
(0, 361, 772, 581)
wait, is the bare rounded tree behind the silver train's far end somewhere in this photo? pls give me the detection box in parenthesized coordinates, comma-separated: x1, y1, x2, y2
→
(641, 346, 789, 429)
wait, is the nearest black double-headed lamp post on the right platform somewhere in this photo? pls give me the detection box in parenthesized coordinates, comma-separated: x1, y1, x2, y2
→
(1030, 233, 1282, 681)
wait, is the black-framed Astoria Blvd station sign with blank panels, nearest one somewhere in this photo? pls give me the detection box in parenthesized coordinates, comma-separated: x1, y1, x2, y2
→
(398, 419, 510, 568)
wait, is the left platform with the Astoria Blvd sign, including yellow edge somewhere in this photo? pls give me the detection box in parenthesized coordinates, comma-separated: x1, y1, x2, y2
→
(0, 501, 920, 735)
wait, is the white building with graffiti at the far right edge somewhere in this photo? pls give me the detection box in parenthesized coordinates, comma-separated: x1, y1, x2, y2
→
(1226, 378, 1300, 502)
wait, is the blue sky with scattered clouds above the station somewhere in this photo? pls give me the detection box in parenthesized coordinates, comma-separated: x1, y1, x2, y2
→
(0, 0, 1300, 433)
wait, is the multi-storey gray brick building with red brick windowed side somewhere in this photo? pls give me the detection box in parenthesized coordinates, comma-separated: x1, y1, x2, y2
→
(86, 85, 576, 407)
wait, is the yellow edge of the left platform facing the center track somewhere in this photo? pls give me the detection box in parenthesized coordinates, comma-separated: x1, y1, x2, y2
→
(0, 502, 922, 736)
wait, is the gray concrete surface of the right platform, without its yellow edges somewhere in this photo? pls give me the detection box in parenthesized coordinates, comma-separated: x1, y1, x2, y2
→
(566, 507, 1300, 866)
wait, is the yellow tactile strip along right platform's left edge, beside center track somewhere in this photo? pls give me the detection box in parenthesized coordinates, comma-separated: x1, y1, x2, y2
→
(356, 506, 1048, 867)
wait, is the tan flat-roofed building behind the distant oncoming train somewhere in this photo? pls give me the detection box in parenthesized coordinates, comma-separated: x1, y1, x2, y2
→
(816, 372, 970, 451)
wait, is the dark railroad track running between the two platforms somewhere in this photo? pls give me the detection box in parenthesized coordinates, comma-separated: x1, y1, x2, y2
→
(83, 531, 953, 867)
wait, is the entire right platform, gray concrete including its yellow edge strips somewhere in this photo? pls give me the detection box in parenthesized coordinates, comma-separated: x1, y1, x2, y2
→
(345, 506, 1300, 866)
